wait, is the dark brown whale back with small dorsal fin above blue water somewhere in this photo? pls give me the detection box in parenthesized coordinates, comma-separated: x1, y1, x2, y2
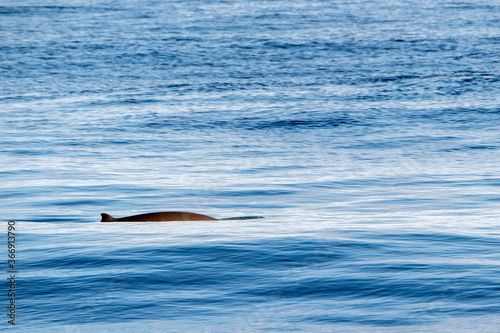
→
(101, 212, 219, 222)
